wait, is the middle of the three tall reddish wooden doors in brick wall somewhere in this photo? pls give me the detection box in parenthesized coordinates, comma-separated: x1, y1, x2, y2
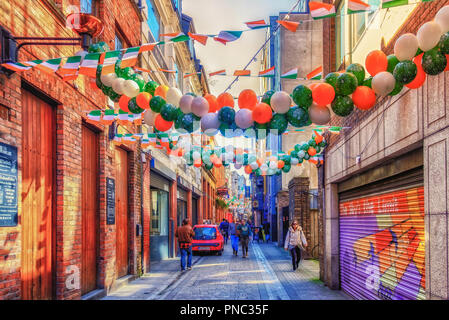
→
(81, 125, 99, 294)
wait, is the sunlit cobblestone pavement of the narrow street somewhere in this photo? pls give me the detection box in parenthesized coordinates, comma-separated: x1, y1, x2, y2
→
(103, 243, 349, 300)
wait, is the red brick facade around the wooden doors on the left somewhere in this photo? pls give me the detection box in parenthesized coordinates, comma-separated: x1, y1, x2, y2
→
(0, 0, 150, 299)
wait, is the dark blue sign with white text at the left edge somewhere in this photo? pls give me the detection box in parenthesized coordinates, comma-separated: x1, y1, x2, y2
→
(0, 143, 18, 227)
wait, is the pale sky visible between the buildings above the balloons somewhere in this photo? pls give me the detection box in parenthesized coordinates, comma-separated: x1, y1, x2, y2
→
(182, 0, 297, 97)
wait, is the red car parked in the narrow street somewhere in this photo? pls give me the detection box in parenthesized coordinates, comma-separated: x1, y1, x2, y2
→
(192, 224, 224, 256)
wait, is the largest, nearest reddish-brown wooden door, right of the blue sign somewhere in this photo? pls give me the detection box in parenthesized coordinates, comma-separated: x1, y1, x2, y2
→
(21, 90, 56, 300)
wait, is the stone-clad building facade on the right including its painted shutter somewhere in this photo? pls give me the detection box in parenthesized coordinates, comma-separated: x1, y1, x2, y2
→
(319, 1, 449, 299)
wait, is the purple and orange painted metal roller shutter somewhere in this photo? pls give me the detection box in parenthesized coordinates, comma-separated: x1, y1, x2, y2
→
(339, 171, 425, 300)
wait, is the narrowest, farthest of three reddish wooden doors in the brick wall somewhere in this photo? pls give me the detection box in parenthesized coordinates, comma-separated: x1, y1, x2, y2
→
(115, 148, 128, 277)
